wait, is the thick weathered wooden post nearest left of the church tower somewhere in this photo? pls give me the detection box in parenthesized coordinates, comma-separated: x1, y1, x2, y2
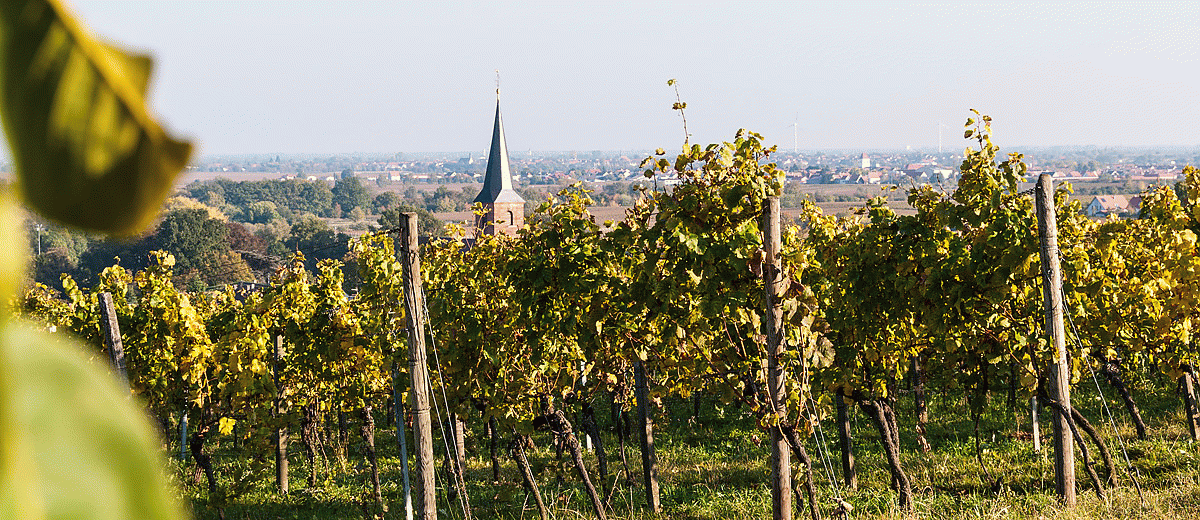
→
(400, 213, 438, 520)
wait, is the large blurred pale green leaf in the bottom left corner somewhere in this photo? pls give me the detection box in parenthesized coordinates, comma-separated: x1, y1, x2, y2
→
(0, 321, 184, 520)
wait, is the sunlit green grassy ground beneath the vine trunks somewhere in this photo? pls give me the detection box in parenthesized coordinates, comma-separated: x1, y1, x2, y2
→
(179, 377, 1200, 519)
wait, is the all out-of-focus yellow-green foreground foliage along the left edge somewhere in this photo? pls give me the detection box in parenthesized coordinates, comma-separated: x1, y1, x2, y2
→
(0, 0, 191, 519)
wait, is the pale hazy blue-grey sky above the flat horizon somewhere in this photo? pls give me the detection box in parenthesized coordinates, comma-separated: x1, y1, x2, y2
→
(73, 0, 1200, 154)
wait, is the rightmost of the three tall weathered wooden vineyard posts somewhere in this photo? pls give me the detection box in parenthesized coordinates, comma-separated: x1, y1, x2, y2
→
(1034, 173, 1075, 507)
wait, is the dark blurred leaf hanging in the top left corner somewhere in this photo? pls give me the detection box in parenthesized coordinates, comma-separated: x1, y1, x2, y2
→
(0, 0, 192, 234)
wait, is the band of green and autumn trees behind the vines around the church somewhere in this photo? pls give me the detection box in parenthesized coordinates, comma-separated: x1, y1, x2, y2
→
(28, 176, 729, 291)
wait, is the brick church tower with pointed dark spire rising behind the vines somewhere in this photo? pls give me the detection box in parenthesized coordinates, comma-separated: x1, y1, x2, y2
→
(474, 96, 524, 235)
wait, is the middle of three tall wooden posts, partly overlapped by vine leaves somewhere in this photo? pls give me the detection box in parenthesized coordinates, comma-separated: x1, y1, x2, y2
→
(762, 197, 792, 520)
